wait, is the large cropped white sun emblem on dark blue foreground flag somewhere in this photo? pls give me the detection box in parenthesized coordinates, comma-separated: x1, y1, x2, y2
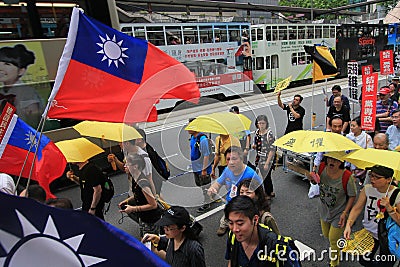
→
(0, 210, 107, 267)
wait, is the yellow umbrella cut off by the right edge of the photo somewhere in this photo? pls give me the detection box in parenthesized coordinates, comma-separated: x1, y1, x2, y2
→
(344, 148, 400, 179)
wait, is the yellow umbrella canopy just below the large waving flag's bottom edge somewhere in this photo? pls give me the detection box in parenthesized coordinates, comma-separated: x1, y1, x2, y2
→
(73, 121, 142, 142)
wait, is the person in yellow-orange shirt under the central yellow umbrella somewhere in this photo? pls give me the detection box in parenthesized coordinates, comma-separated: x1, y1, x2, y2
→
(211, 134, 241, 179)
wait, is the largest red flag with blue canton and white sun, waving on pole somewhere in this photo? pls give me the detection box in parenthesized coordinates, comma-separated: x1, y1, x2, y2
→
(47, 8, 200, 123)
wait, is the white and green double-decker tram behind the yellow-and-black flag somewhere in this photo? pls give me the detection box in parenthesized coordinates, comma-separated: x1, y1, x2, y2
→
(251, 24, 336, 91)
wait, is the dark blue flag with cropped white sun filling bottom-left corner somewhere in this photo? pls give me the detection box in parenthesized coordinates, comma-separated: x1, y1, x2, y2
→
(0, 192, 169, 267)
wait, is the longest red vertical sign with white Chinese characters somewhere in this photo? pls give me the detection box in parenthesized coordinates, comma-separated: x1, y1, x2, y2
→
(361, 73, 378, 131)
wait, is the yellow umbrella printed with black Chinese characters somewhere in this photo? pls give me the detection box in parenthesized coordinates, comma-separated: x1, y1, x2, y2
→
(274, 130, 361, 153)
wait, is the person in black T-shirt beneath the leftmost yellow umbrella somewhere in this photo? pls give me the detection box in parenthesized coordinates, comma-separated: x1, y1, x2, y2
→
(67, 160, 105, 220)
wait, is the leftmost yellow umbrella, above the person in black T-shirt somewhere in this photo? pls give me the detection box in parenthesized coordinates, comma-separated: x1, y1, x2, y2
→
(56, 137, 104, 162)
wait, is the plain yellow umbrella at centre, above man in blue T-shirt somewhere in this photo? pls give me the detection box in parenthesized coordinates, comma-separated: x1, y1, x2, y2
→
(185, 112, 251, 134)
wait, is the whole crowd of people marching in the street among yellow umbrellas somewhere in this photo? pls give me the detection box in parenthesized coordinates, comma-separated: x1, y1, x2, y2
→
(0, 79, 400, 267)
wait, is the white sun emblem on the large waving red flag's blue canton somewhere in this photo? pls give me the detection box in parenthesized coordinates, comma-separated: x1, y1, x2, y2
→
(97, 34, 128, 68)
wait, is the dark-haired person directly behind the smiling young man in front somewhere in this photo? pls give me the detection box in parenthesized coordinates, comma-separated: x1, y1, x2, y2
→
(238, 179, 279, 235)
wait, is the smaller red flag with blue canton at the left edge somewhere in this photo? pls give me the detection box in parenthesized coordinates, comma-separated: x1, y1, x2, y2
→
(0, 114, 67, 197)
